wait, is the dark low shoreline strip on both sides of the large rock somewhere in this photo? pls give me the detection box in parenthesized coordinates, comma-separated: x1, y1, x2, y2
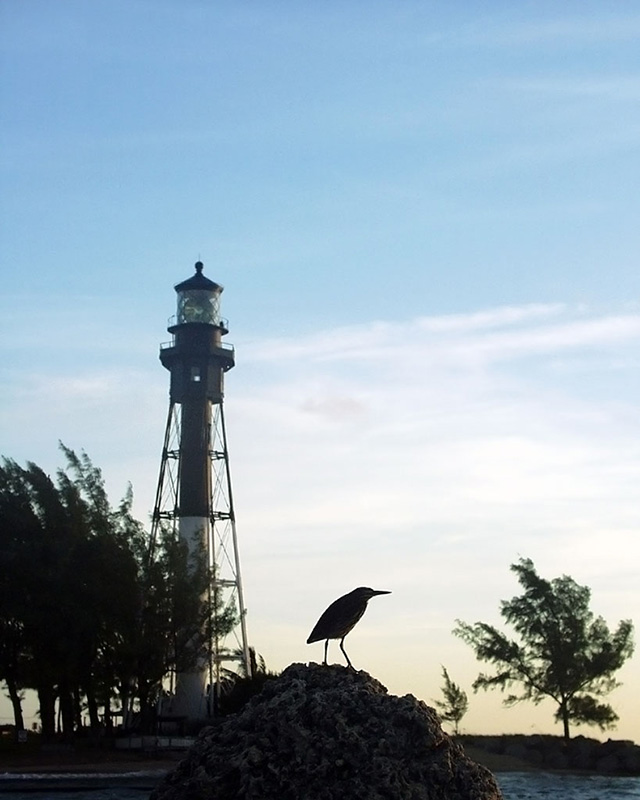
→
(0, 734, 640, 776)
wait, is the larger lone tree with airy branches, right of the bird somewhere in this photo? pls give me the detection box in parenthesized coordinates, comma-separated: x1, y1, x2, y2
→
(453, 558, 633, 740)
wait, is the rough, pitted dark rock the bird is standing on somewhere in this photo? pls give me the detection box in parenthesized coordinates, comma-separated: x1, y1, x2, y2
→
(151, 664, 502, 800)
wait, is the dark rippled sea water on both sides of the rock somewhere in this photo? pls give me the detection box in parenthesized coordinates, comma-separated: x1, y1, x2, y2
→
(0, 772, 640, 800)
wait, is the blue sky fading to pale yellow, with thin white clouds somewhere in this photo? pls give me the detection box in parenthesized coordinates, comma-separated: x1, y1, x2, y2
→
(0, 0, 640, 741)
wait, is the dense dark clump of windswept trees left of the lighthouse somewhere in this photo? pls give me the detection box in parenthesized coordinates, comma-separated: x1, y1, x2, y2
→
(0, 445, 236, 737)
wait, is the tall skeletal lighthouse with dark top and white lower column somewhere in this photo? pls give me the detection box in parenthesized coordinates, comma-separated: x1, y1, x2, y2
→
(151, 261, 250, 722)
